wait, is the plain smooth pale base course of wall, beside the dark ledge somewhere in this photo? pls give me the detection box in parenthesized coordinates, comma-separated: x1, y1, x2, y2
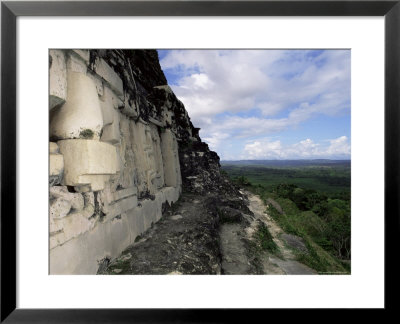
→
(50, 181, 180, 274)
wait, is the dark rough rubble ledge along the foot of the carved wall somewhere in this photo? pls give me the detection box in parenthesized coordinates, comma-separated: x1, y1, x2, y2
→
(100, 194, 221, 274)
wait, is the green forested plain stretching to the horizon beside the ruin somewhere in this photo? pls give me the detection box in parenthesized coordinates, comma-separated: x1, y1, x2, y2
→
(223, 161, 351, 273)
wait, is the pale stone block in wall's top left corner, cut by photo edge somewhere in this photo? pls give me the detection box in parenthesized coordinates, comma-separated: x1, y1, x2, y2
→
(49, 50, 67, 109)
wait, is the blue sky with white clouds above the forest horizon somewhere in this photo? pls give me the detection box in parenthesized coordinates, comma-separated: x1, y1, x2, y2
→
(158, 50, 351, 160)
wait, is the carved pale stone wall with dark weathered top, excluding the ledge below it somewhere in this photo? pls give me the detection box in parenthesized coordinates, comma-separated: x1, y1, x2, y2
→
(49, 49, 206, 274)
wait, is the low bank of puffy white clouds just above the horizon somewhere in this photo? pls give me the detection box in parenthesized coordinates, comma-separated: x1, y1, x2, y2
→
(244, 136, 350, 160)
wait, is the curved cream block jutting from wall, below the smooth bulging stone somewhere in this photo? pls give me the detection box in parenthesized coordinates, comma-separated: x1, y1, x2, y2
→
(58, 139, 119, 191)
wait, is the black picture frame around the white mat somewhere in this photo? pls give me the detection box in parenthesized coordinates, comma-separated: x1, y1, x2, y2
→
(0, 0, 400, 323)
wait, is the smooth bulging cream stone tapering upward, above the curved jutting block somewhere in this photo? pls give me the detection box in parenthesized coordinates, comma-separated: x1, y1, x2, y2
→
(50, 72, 103, 139)
